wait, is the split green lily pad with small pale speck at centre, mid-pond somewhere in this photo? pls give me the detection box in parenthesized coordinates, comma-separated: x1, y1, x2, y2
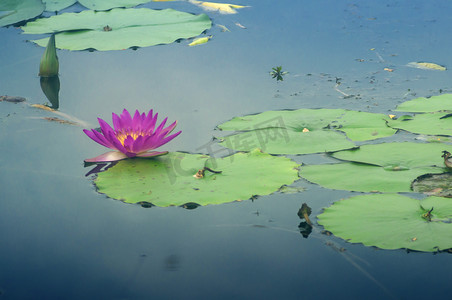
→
(218, 109, 396, 154)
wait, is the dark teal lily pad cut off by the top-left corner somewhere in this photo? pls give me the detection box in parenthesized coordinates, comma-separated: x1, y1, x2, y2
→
(0, 0, 44, 27)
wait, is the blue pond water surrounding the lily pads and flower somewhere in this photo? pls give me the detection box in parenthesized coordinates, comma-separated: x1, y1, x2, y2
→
(0, 0, 452, 299)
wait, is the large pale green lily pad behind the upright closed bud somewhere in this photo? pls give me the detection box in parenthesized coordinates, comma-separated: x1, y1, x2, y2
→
(22, 8, 212, 51)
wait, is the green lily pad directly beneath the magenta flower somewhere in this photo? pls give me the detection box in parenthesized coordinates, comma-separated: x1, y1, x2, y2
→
(95, 150, 299, 206)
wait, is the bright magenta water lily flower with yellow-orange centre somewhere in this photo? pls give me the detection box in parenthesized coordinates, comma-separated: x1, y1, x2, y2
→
(83, 109, 182, 162)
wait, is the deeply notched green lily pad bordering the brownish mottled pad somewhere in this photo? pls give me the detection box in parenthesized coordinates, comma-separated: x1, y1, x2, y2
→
(300, 142, 452, 193)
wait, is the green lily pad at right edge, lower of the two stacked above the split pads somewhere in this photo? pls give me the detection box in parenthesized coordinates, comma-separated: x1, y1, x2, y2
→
(388, 112, 452, 136)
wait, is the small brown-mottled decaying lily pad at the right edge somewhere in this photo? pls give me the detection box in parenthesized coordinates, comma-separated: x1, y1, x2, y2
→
(411, 172, 452, 198)
